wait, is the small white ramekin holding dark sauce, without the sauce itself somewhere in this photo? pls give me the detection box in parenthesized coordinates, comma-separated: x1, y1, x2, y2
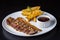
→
(37, 15, 51, 27)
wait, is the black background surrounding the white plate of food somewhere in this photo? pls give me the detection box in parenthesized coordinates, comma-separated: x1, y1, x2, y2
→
(0, 0, 60, 40)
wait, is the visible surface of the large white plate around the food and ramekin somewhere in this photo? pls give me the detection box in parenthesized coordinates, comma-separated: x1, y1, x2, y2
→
(2, 11, 57, 36)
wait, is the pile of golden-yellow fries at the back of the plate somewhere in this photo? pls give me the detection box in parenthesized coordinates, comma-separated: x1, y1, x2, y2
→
(22, 6, 43, 22)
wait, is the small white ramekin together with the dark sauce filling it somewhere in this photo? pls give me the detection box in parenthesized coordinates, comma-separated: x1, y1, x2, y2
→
(37, 15, 51, 27)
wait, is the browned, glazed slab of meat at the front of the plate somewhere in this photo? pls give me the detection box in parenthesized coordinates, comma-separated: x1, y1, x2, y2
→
(6, 17, 42, 35)
